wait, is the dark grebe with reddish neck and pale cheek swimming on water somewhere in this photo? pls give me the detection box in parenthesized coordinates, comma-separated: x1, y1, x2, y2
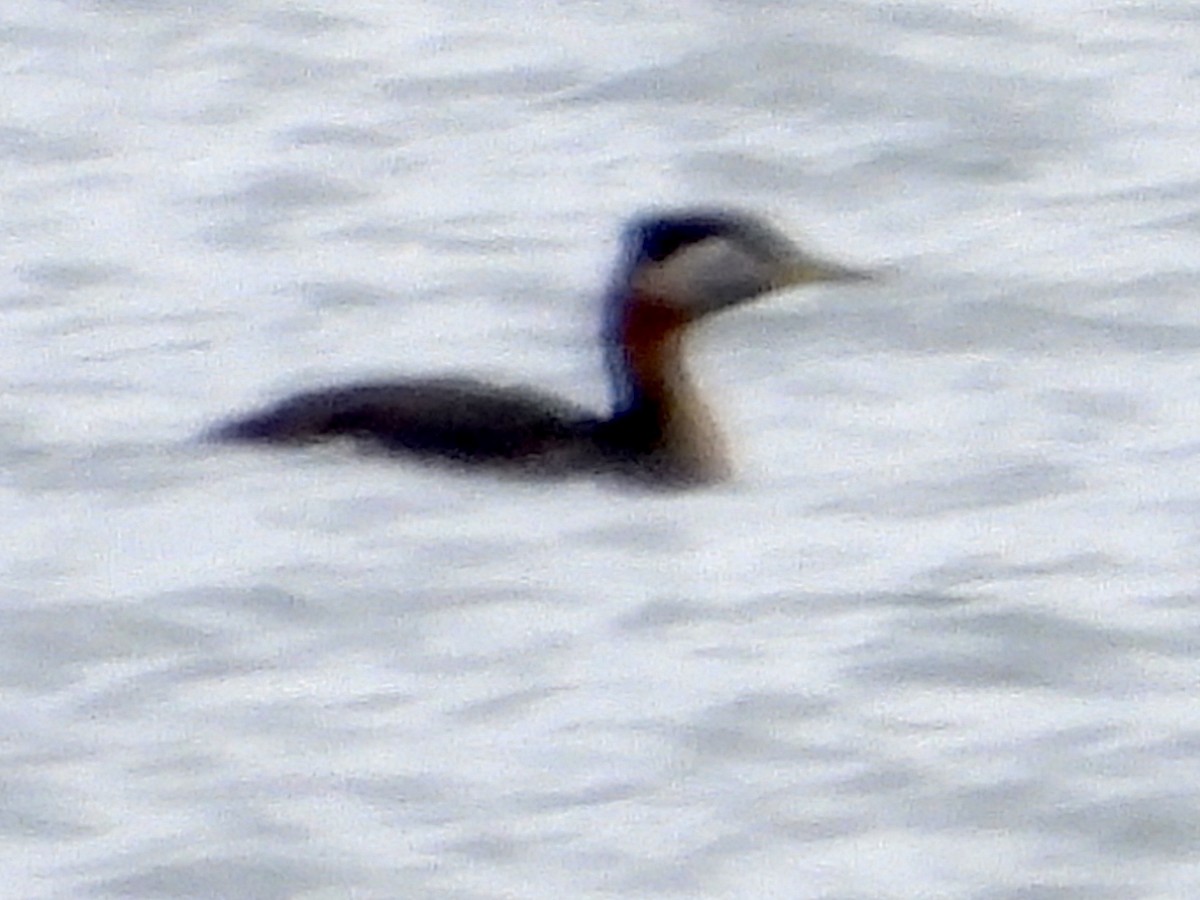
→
(214, 210, 869, 486)
